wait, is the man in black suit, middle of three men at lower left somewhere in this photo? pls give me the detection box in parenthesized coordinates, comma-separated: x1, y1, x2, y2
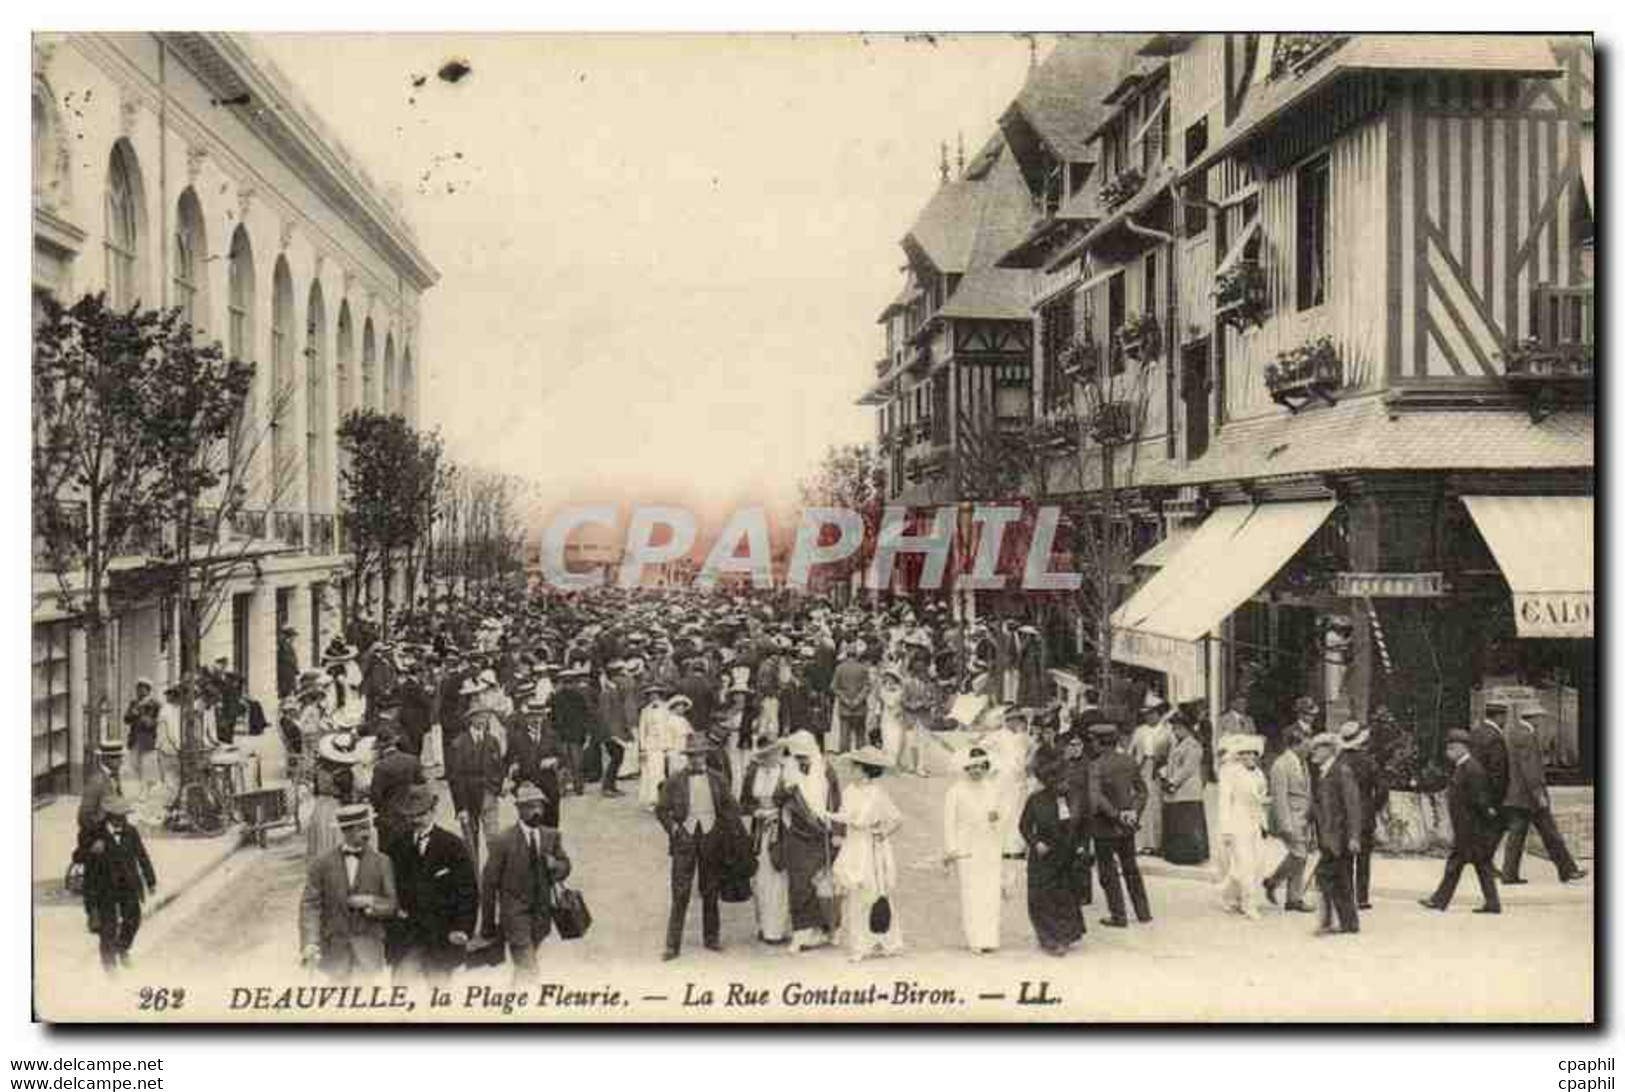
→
(385, 785, 479, 983)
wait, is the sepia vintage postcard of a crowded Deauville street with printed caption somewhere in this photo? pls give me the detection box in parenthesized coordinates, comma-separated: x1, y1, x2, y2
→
(31, 31, 1602, 1025)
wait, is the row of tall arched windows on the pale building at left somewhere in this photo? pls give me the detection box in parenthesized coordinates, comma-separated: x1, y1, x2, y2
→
(52, 121, 416, 512)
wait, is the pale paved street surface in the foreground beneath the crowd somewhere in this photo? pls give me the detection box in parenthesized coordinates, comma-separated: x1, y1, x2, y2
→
(37, 763, 1593, 1021)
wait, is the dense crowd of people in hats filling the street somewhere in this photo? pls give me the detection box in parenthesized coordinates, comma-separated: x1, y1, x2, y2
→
(66, 588, 1584, 980)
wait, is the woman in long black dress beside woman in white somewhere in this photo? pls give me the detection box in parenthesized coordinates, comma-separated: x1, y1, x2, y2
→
(1021, 757, 1089, 956)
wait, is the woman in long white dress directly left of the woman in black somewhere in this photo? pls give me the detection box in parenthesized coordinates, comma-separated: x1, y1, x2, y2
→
(943, 746, 1004, 956)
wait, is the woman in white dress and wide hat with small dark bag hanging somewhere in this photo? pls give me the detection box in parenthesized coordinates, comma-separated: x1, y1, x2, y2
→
(827, 748, 904, 964)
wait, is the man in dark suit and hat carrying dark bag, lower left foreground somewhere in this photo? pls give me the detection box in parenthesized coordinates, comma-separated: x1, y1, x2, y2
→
(479, 785, 570, 982)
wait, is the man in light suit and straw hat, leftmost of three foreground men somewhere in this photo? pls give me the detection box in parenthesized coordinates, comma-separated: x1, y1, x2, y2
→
(299, 804, 398, 982)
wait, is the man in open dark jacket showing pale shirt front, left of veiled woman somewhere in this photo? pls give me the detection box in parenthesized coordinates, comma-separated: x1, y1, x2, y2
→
(655, 731, 739, 960)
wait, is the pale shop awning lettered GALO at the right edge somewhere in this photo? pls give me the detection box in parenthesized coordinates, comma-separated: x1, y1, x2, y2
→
(1461, 497, 1596, 637)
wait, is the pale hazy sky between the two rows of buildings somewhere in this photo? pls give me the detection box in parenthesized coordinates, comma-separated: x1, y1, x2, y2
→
(260, 34, 1050, 529)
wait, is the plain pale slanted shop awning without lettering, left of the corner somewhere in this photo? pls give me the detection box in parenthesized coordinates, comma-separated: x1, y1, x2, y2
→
(1112, 501, 1337, 670)
